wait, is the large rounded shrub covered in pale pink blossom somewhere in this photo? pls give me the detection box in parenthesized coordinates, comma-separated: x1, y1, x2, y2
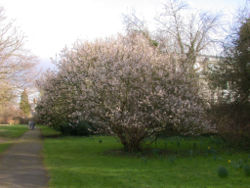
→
(37, 34, 210, 151)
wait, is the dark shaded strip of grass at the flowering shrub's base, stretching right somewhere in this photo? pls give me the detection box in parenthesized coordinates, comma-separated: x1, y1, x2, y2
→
(103, 137, 242, 159)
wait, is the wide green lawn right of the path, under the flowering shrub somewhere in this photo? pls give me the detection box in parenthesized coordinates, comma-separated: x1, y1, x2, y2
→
(42, 128, 250, 188)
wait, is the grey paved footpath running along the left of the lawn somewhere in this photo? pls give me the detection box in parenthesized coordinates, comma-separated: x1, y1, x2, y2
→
(0, 129, 49, 188)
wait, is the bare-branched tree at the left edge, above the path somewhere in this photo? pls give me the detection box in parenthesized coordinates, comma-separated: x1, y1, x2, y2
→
(0, 7, 36, 107)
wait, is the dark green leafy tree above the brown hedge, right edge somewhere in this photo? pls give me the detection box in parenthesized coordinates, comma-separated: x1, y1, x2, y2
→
(210, 17, 250, 104)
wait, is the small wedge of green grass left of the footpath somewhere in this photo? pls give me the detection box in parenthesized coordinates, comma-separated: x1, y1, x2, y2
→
(0, 125, 28, 153)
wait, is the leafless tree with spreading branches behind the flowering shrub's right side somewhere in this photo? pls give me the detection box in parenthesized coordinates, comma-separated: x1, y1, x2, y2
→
(156, 0, 219, 73)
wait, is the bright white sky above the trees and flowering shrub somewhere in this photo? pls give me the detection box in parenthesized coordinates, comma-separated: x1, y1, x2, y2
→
(0, 0, 246, 67)
